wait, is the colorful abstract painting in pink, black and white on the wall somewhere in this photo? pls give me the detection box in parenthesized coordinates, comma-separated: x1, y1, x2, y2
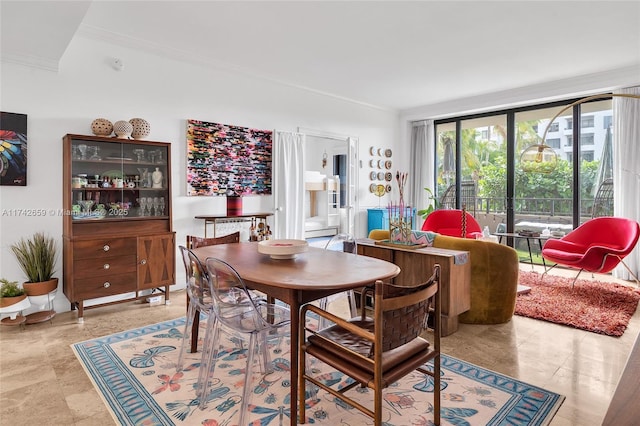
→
(187, 120, 273, 196)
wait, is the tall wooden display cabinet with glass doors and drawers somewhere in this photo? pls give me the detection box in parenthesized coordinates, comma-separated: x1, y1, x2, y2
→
(62, 134, 175, 322)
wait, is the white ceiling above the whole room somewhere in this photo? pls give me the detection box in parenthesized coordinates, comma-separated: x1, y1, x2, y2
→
(0, 0, 640, 110)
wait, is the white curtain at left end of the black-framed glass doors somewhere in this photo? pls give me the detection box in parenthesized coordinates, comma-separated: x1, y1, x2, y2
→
(409, 120, 435, 229)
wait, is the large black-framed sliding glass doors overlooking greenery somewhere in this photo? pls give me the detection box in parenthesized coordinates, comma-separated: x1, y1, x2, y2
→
(434, 94, 613, 256)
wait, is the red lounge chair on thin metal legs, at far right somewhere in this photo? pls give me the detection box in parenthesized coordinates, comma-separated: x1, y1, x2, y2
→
(542, 217, 640, 283)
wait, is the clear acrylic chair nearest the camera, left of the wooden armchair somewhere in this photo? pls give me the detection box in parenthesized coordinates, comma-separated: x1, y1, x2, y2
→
(198, 257, 291, 425)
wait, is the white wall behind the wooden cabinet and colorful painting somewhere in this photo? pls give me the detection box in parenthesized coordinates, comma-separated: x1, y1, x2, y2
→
(0, 37, 400, 313)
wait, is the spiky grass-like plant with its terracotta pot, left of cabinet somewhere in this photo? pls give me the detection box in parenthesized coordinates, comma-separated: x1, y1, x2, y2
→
(11, 232, 58, 296)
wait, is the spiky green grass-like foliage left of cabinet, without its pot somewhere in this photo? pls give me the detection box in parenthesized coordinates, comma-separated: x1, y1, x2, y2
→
(11, 232, 58, 283)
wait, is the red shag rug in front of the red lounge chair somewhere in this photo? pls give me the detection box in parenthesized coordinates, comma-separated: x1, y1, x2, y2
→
(515, 271, 640, 336)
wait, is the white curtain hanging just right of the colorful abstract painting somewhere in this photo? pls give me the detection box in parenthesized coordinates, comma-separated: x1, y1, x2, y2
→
(273, 131, 304, 240)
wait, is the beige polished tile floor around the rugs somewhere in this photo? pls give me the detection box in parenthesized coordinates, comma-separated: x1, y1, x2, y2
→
(0, 265, 640, 426)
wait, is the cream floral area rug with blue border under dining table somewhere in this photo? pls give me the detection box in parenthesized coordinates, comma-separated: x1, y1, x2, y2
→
(71, 317, 564, 426)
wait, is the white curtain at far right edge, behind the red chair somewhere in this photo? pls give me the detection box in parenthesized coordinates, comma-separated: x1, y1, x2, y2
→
(613, 87, 640, 280)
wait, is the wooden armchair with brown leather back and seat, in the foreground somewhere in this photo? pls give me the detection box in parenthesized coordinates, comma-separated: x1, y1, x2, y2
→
(298, 264, 441, 426)
